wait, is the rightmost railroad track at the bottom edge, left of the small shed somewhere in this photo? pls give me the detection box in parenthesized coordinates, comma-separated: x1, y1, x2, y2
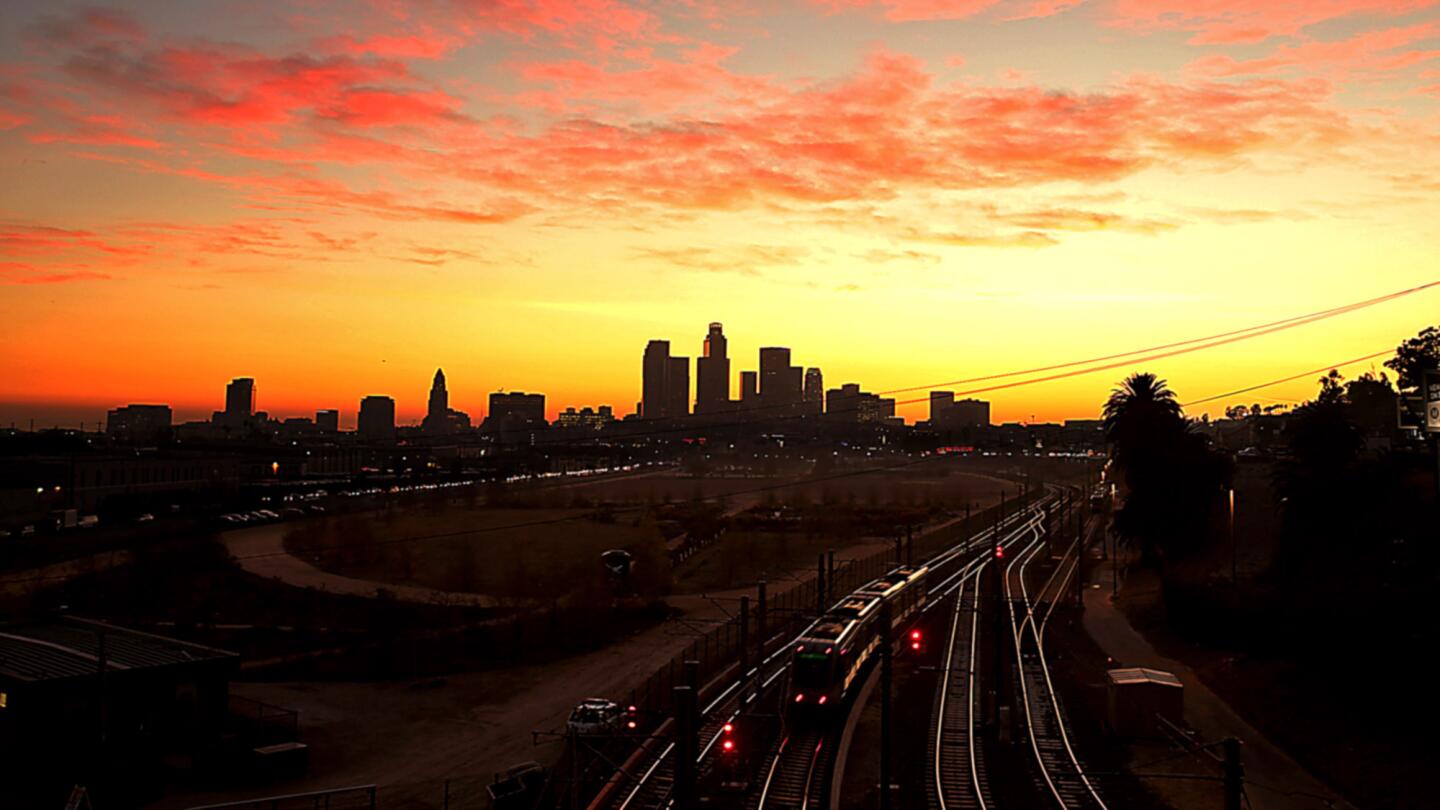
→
(1004, 518, 1107, 810)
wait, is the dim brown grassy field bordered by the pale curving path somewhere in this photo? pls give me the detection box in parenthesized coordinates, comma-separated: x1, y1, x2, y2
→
(285, 460, 1017, 601)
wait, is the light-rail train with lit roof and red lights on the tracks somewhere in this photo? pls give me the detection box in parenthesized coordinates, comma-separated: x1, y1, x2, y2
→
(786, 566, 929, 716)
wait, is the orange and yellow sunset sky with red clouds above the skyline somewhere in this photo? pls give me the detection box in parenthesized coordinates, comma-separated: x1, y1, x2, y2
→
(0, 0, 1440, 424)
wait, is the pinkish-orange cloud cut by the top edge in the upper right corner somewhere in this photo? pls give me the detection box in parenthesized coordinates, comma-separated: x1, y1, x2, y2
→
(1110, 0, 1440, 45)
